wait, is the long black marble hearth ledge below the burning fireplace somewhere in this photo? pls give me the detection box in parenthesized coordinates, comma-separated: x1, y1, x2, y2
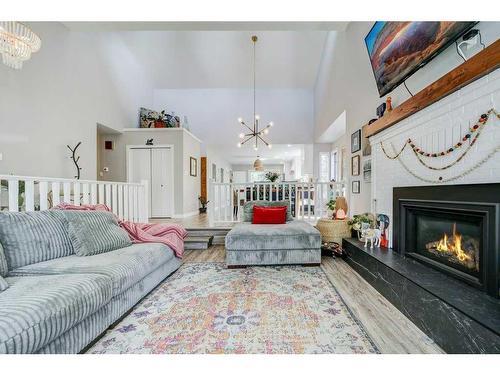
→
(343, 239, 500, 353)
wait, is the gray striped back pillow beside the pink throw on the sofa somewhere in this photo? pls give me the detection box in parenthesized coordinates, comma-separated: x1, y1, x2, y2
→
(63, 211, 132, 256)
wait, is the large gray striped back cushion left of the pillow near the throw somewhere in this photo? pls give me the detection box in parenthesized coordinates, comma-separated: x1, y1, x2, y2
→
(0, 211, 73, 270)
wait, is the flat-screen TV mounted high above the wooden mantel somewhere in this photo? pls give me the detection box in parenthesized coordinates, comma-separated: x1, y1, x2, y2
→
(365, 21, 476, 97)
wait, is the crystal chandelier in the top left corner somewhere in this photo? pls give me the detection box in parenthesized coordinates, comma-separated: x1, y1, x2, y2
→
(0, 21, 42, 69)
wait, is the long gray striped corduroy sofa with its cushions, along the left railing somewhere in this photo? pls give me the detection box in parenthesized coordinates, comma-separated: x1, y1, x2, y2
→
(0, 210, 181, 353)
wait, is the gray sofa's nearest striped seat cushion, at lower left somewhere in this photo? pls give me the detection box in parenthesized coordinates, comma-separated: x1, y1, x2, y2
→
(0, 274, 111, 353)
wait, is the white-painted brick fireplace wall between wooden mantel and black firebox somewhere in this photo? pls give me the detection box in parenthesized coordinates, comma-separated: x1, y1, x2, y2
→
(370, 69, 500, 248)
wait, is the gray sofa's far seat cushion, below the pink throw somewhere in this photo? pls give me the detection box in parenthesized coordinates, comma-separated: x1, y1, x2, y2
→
(9, 243, 174, 296)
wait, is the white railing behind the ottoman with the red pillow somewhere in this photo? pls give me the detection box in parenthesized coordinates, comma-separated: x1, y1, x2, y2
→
(208, 181, 346, 225)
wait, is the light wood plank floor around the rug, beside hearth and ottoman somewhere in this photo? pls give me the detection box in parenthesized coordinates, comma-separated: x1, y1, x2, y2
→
(184, 246, 443, 354)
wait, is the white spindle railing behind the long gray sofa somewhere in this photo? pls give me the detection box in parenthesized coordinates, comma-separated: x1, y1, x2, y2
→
(0, 175, 149, 222)
